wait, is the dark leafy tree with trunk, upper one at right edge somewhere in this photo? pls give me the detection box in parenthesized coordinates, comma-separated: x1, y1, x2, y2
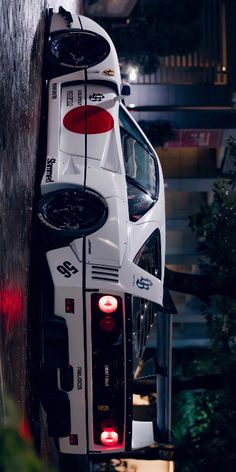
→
(165, 136, 236, 300)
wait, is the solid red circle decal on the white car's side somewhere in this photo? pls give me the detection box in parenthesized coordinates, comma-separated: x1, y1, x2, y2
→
(63, 105, 114, 134)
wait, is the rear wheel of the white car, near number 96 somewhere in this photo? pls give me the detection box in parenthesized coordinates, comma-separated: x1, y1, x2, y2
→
(38, 188, 108, 243)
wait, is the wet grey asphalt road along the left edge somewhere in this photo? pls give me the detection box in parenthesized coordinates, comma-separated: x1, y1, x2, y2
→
(0, 0, 80, 464)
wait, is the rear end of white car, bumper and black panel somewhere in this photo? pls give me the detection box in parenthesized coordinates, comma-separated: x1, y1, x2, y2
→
(41, 248, 132, 454)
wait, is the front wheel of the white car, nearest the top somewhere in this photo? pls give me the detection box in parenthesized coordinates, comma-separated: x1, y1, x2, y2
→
(47, 29, 110, 70)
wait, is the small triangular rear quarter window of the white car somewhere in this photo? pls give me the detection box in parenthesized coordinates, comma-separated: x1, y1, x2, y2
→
(134, 229, 161, 279)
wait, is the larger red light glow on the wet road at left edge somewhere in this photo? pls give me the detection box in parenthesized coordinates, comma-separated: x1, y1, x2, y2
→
(0, 288, 23, 332)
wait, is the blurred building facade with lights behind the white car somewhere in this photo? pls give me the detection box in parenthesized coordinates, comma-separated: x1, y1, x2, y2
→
(123, 0, 236, 347)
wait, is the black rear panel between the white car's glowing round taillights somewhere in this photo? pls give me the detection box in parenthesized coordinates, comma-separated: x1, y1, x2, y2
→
(91, 293, 126, 445)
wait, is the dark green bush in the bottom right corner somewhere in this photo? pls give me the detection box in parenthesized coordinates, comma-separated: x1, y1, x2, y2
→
(172, 334, 236, 472)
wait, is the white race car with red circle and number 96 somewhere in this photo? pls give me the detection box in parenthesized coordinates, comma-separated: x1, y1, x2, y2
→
(38, 5, 165, 455)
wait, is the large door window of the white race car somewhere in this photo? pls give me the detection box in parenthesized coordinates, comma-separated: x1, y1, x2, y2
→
(119, 107, 159, 221)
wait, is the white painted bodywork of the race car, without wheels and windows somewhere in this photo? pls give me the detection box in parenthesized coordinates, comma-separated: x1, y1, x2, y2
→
(41, 8, 165, 454)
